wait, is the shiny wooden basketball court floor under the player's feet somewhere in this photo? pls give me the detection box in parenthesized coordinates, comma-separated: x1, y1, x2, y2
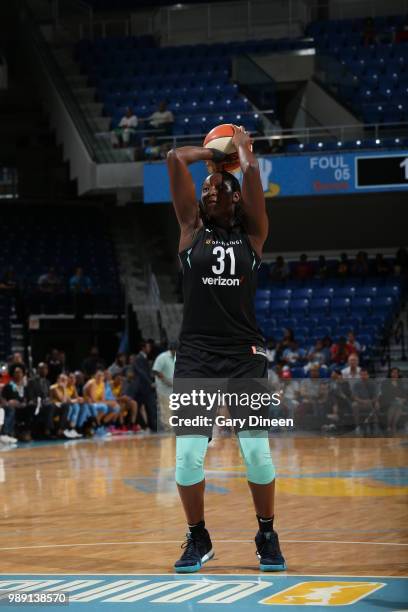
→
(0, 436, 408, 610)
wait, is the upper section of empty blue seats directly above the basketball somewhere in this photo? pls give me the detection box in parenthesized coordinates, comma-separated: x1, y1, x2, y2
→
(76, 37, 310, 135)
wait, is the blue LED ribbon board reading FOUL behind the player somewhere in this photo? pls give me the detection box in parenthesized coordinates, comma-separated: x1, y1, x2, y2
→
(143, 149, 408, 204)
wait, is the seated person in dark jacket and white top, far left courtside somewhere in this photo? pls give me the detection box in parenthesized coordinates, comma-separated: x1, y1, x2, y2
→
(1, 363, 31, 442)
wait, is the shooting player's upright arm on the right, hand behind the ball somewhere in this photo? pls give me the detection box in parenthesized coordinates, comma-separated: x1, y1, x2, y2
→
(232, 126, 268, 255)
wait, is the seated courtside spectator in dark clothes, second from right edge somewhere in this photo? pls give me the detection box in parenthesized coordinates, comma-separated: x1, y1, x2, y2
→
(351, 368, 380, 435)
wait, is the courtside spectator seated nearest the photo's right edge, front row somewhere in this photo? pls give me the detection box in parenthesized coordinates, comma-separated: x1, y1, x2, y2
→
(380, 368, 408, 436)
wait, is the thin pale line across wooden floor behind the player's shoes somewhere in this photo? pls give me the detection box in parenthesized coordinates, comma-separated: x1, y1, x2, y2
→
(0, 540, 408, 552)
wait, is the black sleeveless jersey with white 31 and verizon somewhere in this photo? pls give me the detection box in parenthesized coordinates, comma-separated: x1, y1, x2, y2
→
(179, 226, 264, 355)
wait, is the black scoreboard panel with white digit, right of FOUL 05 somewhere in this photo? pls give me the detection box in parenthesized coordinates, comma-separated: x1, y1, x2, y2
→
(356, 151, 408, 189)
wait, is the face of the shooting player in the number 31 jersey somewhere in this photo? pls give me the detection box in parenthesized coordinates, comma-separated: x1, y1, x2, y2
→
(201, 173, 240, 221)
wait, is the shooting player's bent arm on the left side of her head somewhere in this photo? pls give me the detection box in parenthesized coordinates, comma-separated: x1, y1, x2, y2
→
(167, 147, 222, 231)
